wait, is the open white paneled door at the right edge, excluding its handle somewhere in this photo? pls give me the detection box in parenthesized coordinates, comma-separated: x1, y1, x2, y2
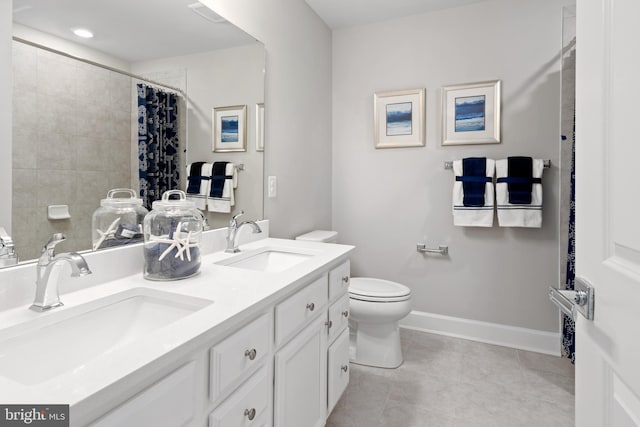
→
(576, 0, 640, 427)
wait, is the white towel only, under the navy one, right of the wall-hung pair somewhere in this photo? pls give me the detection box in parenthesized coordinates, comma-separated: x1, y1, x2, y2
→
(496, 159, 544, 228)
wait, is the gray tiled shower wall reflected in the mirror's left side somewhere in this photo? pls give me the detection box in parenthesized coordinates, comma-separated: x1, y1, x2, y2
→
(12, 42, 131, 261)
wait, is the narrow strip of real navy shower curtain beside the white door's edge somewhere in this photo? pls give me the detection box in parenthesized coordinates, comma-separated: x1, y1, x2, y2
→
(562, 116, 576, 363)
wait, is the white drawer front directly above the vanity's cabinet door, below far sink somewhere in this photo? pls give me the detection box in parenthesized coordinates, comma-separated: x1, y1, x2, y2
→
(276, 274, 328, 345)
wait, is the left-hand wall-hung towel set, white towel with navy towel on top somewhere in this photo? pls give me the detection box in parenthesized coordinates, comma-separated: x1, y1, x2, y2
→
(453, 158, 495, 227)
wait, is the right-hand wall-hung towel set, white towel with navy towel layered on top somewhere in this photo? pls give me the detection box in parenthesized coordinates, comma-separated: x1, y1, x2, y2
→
(496, 157, 544, 228)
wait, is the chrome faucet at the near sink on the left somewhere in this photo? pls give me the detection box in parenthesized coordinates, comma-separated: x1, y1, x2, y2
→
(29, 233, 91, 311)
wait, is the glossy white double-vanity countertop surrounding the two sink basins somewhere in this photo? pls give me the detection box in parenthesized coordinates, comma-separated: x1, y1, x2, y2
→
(0, 238, 353, 406)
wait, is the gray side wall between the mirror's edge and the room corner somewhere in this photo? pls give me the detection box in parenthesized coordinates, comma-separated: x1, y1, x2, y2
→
(202, 0, 332, 237)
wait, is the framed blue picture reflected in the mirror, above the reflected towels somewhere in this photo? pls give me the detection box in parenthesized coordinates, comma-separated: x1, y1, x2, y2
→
(212, 105, 247, 153)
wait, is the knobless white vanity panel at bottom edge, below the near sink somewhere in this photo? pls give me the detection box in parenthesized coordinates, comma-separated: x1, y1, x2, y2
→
(91, 362, 197, 427)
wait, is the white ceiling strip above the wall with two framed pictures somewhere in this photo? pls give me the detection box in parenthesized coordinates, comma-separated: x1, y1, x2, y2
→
(305, 0, 496, 29)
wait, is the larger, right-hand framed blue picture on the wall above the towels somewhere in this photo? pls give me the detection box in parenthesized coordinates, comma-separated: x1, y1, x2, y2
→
(442, 80, 500, 145)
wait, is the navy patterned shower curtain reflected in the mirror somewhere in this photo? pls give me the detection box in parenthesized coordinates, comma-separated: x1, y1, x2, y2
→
(138, 84, 180, 209)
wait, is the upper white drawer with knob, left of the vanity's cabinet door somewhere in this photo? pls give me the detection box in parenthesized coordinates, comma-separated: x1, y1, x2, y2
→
(209, 313, 271, 401)
